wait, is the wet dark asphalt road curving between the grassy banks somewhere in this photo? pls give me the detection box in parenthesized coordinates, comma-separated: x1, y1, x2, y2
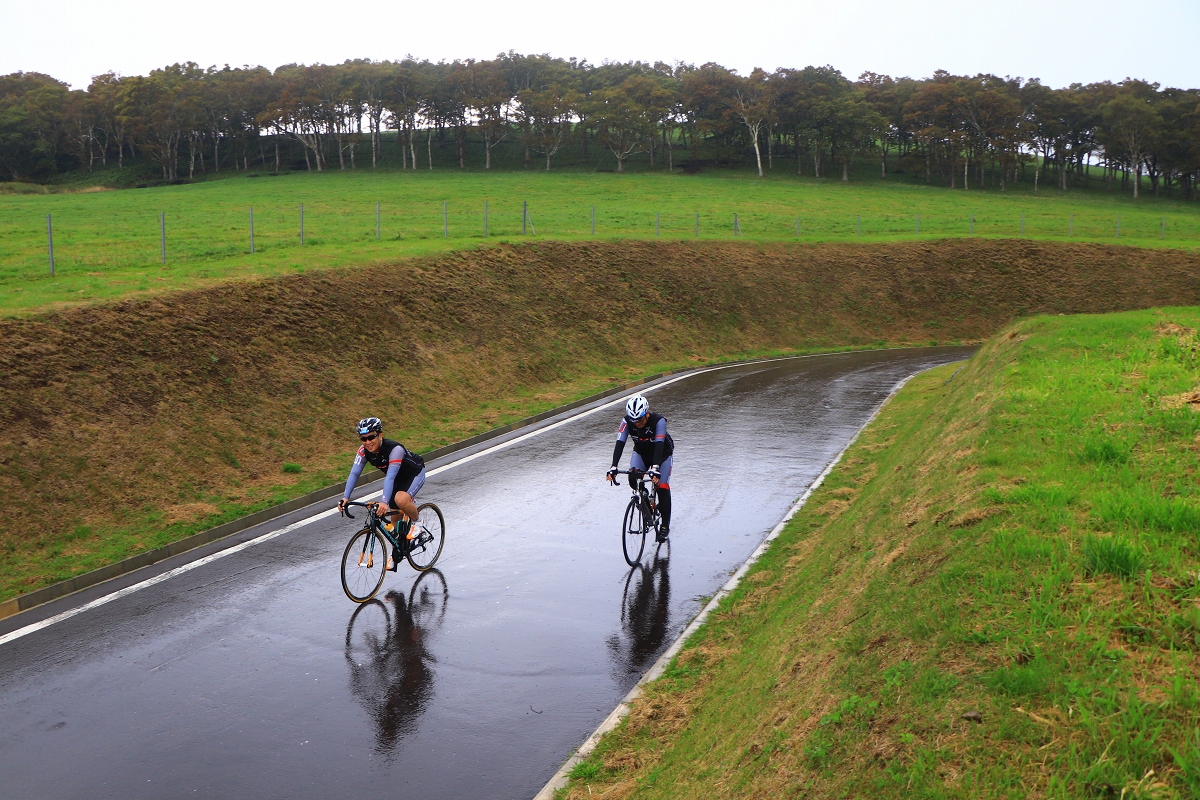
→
(0, 348, 970, 800)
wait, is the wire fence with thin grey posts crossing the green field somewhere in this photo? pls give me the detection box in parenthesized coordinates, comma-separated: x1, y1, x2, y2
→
(0, 198, 1200, 282)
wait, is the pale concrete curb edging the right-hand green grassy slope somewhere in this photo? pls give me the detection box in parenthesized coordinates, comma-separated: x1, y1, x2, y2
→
(534, 371, 924, 800)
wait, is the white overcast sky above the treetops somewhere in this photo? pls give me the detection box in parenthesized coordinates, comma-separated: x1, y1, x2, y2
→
(0, 0, 1200, 89)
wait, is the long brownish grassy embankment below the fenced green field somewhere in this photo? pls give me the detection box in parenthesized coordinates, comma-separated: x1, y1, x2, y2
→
(0, 240, 1200, 606)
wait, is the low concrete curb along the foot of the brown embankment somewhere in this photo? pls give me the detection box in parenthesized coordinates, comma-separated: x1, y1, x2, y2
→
(0, 348, 849, 620)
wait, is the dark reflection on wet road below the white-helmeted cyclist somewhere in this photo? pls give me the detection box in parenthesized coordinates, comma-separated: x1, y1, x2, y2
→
(608, 549, 671, 679)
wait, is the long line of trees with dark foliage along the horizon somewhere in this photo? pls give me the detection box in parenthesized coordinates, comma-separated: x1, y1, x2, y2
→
(0, 53, 1200, 199)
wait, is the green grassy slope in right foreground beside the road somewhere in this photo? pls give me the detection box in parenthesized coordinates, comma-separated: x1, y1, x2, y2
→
(556, 308, 1200, 798)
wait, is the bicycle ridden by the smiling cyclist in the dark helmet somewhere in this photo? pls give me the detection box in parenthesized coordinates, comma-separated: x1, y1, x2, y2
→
(342, 503, 446, 603)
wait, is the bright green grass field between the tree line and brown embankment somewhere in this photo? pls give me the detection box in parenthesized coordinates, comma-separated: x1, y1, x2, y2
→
(0, 169, 1200, 315)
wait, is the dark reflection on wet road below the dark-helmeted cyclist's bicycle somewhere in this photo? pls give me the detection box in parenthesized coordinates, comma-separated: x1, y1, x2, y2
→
(346, 570, 446, 753)
